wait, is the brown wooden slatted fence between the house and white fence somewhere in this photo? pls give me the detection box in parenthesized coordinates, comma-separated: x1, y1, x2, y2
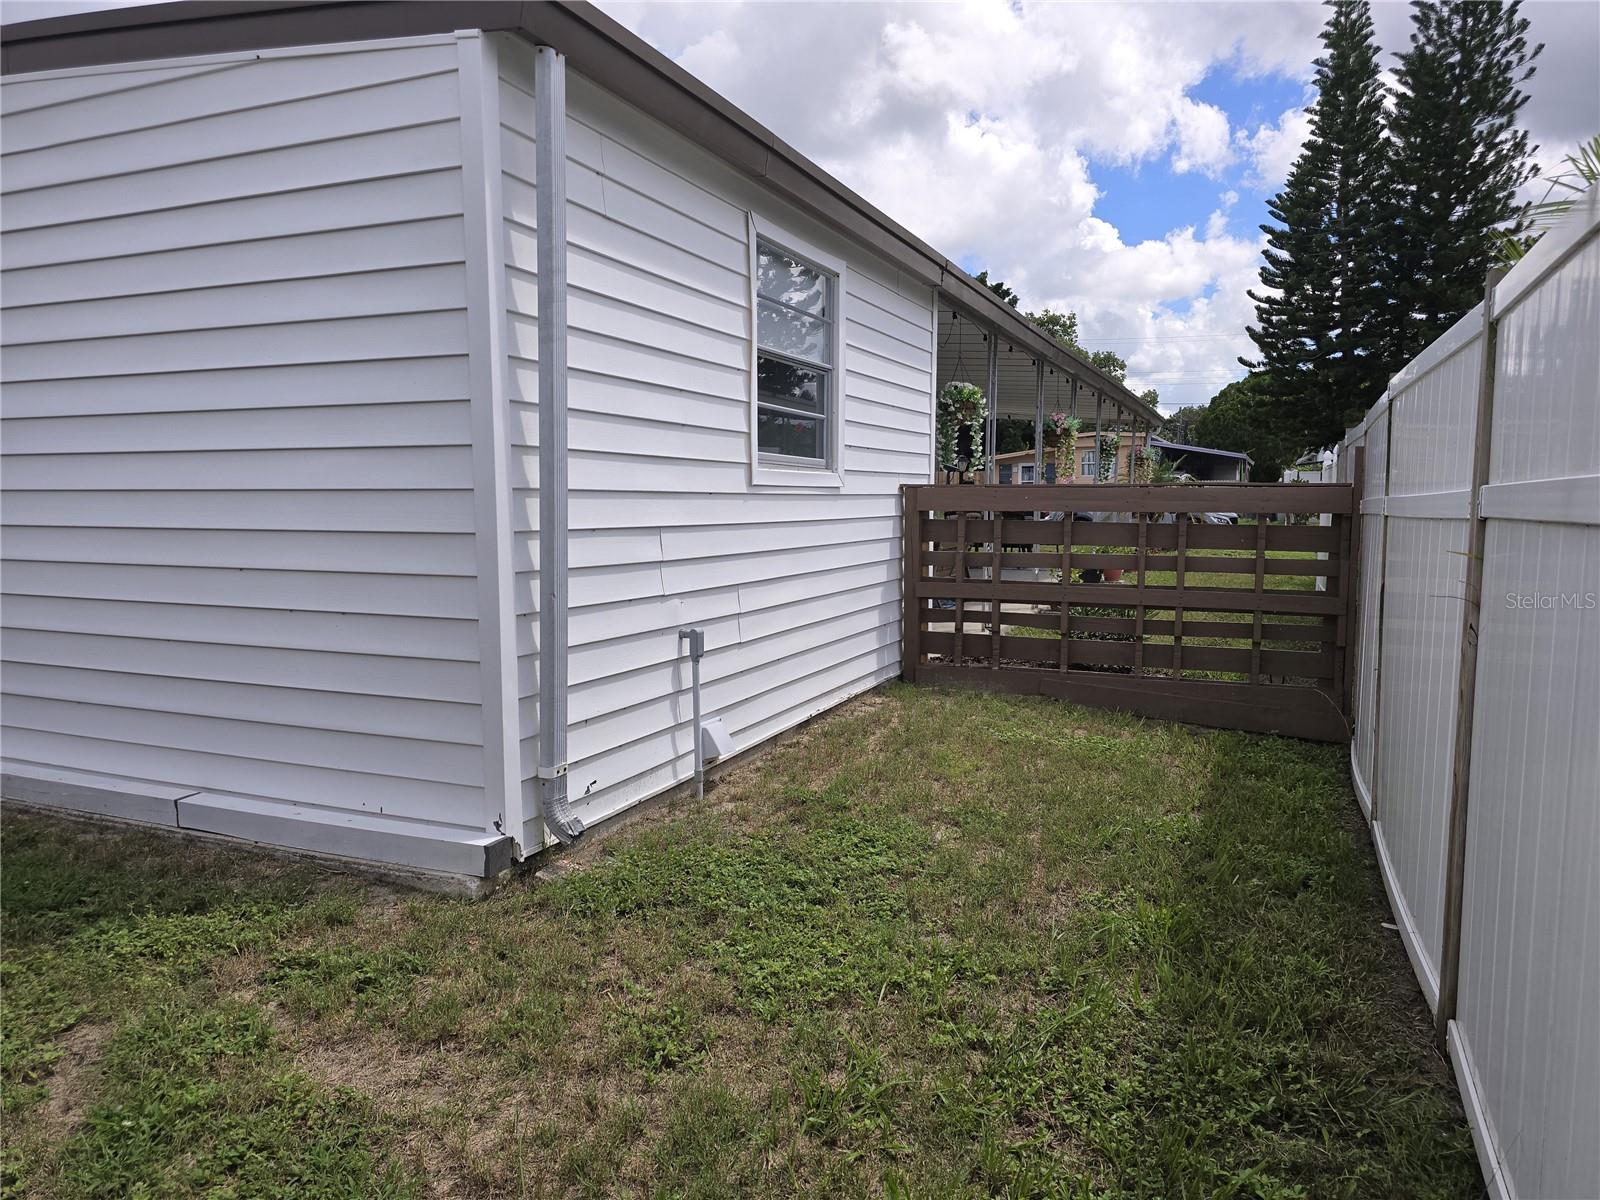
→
(901, 483, 1360, 741)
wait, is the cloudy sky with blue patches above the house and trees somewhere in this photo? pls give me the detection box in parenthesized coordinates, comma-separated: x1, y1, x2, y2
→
(12, 0, 1600, 411)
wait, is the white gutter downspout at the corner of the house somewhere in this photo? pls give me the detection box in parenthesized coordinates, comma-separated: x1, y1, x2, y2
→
(533, 46, 584, 845)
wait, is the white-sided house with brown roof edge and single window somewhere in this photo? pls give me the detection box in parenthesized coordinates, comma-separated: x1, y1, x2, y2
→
(0, 2, 1158, 875)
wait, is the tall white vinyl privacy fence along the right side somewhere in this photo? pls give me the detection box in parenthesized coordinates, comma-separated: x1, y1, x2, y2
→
(1338, 195, 1600, 1200)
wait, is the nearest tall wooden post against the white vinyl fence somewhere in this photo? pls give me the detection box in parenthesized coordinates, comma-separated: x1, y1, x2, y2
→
(1434, 267, 1506, 1048)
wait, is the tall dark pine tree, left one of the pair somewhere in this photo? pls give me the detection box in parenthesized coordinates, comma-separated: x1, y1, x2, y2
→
(1242, 0, 1389, 448)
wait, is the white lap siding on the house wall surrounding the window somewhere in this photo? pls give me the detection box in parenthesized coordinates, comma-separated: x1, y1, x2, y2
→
(501, 43, 933, 851)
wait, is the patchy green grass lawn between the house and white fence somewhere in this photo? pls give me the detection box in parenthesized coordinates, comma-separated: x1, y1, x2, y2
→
(0, 686, 1482, 1200)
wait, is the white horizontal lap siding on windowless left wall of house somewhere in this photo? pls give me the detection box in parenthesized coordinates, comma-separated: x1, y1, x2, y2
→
(0, 40, 483, 829)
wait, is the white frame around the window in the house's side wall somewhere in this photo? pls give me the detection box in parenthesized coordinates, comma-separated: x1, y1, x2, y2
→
(749, 213, 848, 490)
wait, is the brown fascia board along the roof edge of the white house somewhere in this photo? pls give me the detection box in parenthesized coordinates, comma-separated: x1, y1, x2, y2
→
(0, 0, 1160, 422)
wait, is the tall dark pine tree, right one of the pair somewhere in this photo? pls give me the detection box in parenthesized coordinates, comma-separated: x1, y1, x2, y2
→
(1389, 0, 1544, 368)
